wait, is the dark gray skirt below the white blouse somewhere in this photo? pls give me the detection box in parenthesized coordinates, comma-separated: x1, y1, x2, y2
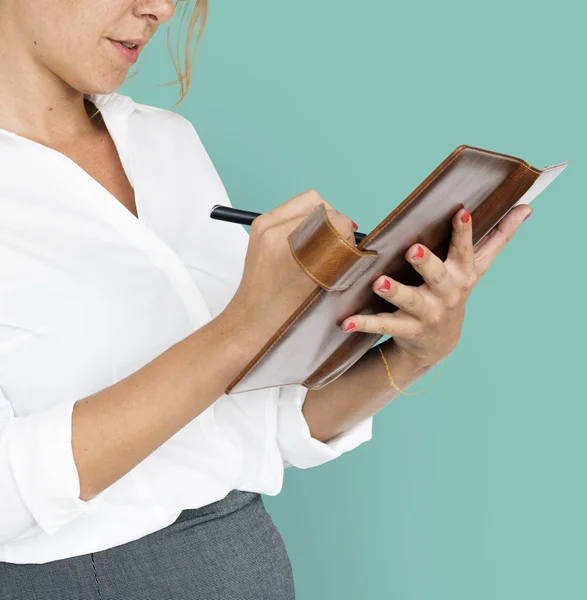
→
(0, 490, 295, 600)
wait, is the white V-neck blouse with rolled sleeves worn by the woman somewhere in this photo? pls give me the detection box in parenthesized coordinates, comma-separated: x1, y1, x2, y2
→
(0, 92, 372, 563)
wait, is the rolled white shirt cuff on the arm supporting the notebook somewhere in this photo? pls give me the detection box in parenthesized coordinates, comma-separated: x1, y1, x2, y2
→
(277, 384, 373, 469)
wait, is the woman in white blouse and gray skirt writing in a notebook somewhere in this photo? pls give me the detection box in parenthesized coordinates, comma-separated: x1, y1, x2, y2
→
(0, 0, 531, 600)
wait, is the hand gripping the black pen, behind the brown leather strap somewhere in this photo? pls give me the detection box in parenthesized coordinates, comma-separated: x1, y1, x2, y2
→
(222, 190, 355, 349)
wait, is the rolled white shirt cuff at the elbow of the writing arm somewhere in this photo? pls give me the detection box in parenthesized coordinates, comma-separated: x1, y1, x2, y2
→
(3, 400, 103, 535)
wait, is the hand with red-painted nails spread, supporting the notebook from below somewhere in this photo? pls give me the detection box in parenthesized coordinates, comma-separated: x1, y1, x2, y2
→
(340, 204, 532, 369)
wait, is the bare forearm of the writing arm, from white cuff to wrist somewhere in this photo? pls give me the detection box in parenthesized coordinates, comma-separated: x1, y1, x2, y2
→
(72, 319, 253, 500)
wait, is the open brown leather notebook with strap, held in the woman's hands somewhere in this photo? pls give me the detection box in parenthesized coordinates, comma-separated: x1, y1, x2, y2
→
(226, 146, 569, 393)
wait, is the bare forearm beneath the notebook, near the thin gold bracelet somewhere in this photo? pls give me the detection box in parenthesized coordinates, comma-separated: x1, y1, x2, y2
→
(302, 340, 430, 442)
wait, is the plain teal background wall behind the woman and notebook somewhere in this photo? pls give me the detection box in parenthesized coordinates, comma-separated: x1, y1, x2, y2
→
(120, 0, 587, 600)
